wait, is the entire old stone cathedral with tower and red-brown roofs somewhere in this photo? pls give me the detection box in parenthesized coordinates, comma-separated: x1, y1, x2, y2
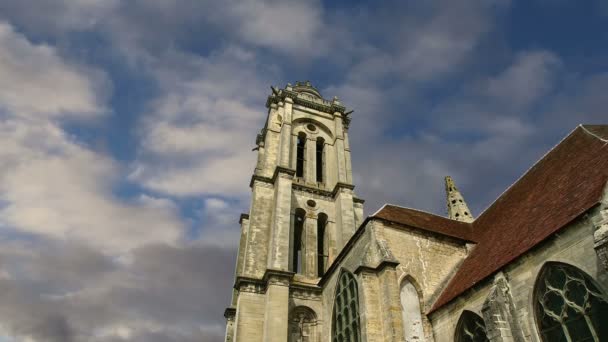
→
(224, 82, 608, 342)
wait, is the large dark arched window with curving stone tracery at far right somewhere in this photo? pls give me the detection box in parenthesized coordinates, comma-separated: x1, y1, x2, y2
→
(534, 262, 608, 342)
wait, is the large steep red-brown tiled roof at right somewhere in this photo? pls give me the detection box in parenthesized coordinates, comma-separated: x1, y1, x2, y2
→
(431, 125, 608, 312)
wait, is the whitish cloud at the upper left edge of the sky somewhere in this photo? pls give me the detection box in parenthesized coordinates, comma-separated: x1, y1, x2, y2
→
(0, 21, 107, 119)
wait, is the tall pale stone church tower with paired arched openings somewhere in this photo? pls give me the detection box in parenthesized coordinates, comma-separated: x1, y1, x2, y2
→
(224, 82, 363, 342)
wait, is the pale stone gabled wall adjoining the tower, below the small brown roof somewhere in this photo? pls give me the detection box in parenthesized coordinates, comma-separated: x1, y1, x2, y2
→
(323, 220, 466, 341)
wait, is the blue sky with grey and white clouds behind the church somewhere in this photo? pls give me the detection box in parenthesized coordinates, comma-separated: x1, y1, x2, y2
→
(0, 0, 608, 342)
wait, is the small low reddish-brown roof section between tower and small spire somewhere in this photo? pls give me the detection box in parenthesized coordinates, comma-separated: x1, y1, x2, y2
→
(371, 204, 476, 242)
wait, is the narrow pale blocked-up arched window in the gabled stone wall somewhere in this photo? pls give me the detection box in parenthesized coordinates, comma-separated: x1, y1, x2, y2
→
(401, 279, 424, 342)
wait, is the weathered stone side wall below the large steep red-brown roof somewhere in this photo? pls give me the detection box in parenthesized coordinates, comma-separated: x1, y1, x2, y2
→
(430, 204, 608, 342)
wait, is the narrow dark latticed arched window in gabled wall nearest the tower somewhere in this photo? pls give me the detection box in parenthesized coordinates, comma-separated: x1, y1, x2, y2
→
(331, 271, 361, 342)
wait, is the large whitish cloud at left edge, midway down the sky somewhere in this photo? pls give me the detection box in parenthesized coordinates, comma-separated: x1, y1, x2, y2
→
(0, 120, 181, 250)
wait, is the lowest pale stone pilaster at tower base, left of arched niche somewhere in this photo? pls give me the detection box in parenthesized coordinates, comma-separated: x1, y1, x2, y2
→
(263, 271, 292, 342)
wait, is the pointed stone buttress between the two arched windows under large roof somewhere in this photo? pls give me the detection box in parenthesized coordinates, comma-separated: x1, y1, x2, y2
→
(481, 272, 524, 342)
